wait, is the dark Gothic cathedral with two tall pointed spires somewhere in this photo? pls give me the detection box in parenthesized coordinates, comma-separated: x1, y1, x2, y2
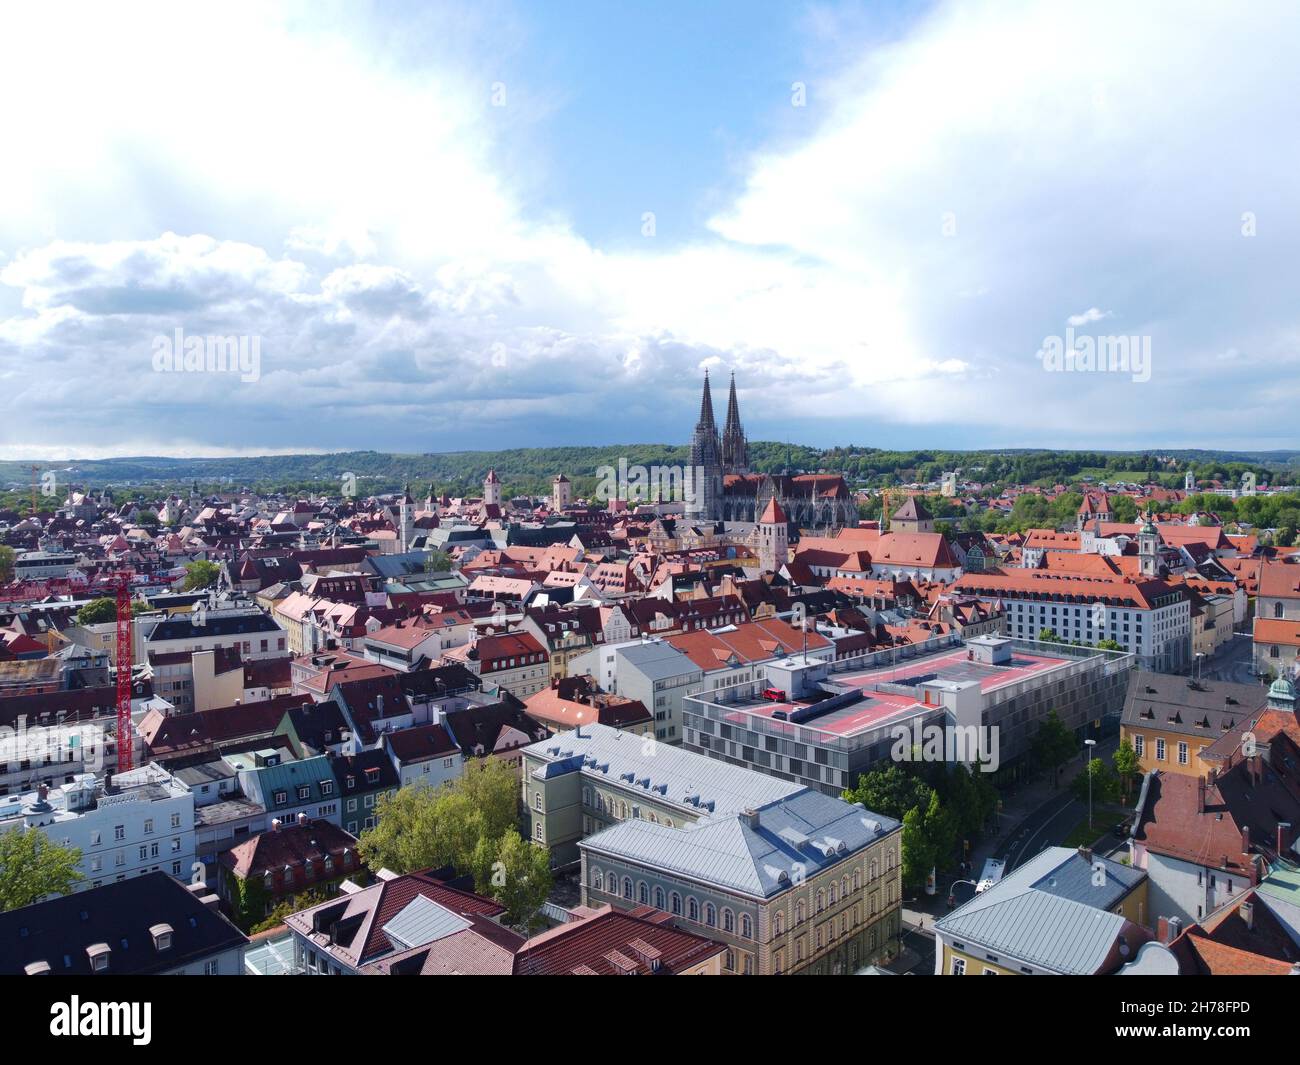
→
(686, 371, 858, 531)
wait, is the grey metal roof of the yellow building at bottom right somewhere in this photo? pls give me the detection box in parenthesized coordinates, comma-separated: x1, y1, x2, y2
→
(935, 847, 1145, 974)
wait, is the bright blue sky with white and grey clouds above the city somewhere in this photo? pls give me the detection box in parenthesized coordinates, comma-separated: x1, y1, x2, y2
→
(0, 0, 1300, 459)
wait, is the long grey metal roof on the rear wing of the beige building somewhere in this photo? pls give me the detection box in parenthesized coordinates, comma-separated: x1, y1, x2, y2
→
(524, 724, 795, 817)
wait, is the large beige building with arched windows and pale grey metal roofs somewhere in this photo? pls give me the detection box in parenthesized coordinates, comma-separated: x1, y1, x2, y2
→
(523, 726, 902, 974)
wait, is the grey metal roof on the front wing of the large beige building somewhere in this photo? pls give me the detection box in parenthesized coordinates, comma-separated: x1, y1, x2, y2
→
(580, 788, 898, 899)
